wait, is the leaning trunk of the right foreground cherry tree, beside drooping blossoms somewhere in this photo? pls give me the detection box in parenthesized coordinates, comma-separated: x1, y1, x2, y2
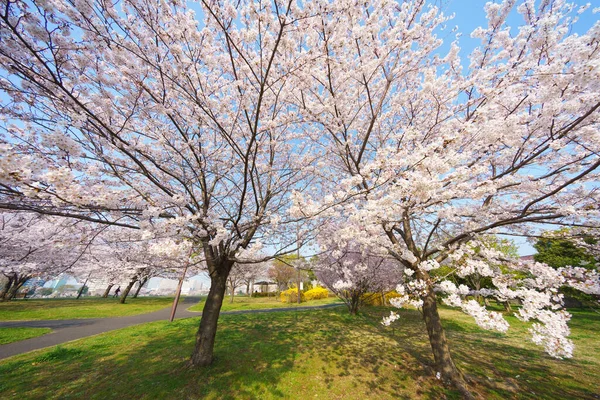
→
(422, 285, 473, 399)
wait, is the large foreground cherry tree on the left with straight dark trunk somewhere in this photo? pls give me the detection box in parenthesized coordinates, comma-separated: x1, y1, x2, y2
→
(0, 0, 316, 366)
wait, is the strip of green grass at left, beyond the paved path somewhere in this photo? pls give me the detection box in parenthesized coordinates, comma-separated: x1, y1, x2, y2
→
(0, 297, 173, 321)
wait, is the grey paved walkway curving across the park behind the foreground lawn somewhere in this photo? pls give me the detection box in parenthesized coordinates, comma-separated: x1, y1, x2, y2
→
(0, 297, 341, 360)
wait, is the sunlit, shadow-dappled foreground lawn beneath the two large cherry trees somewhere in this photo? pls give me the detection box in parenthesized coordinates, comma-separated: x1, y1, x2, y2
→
(0, 307, 600, 399)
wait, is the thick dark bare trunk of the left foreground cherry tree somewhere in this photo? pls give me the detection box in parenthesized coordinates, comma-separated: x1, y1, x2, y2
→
(189, 261, 233, 367)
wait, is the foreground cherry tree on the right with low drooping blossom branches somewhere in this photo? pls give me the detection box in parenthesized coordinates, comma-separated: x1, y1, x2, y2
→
(293, 0, 600, 396)
